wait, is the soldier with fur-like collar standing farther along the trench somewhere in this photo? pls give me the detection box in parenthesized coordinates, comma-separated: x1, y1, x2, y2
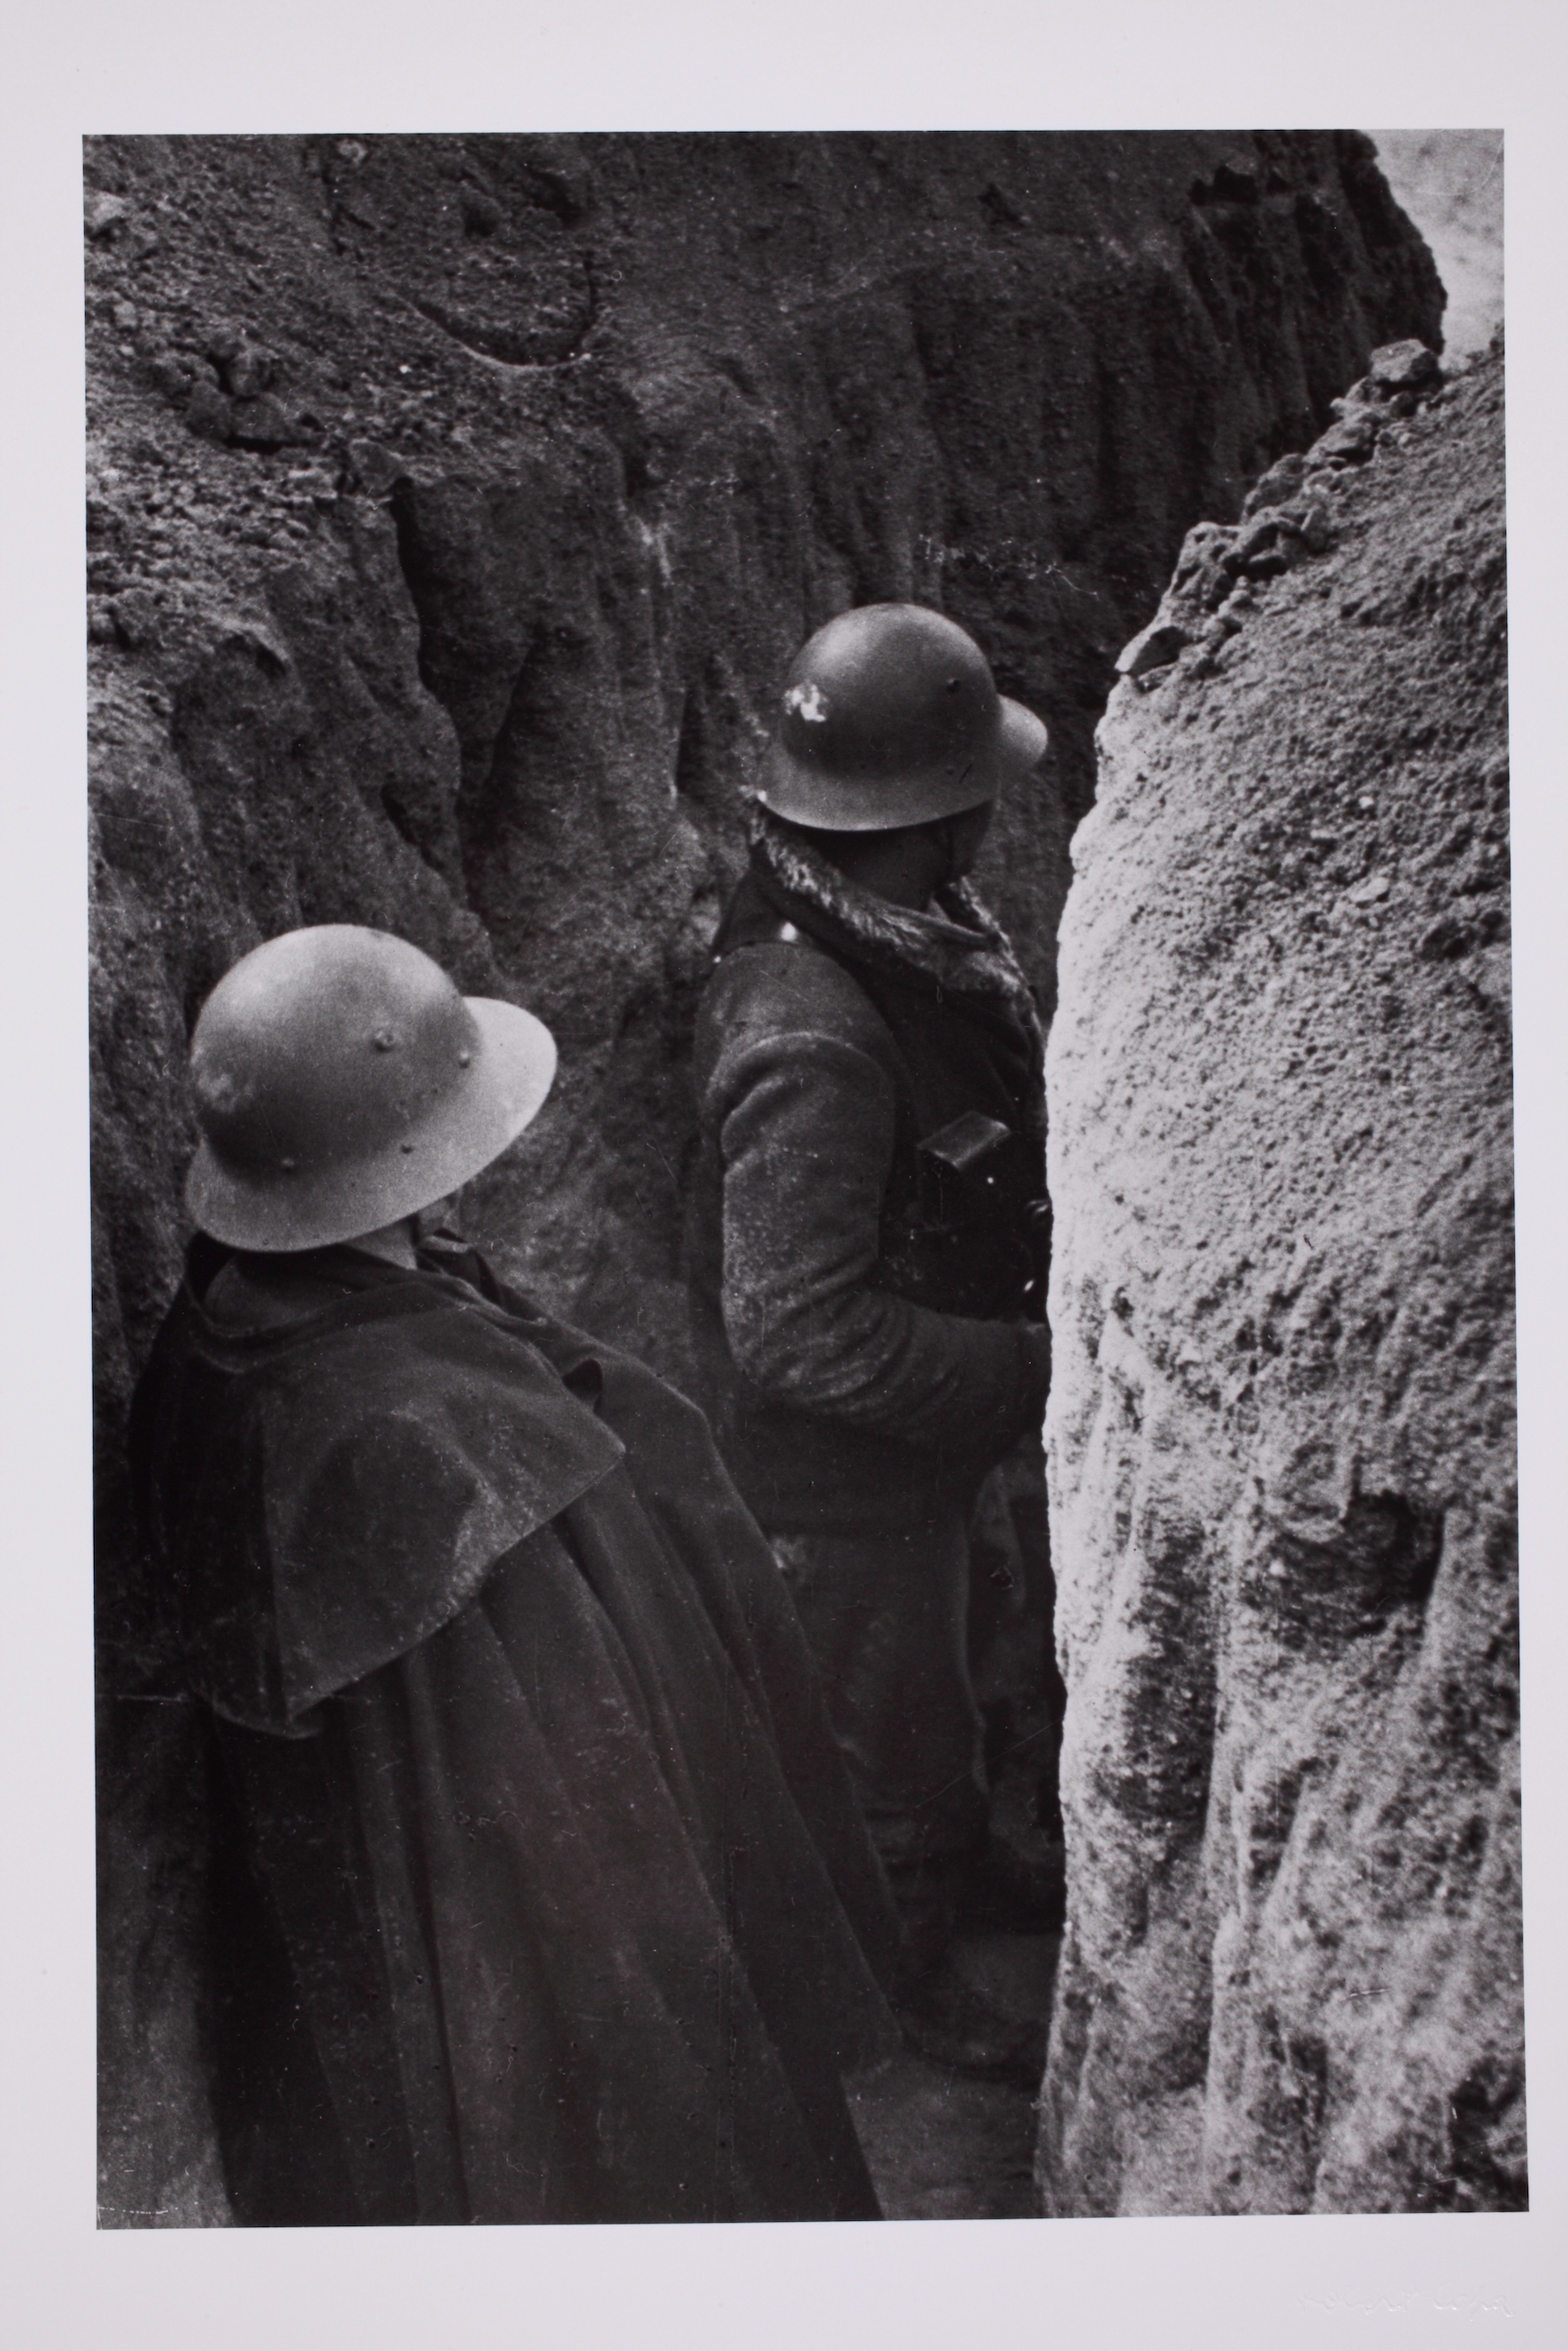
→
(688, 604, 1051, 2073)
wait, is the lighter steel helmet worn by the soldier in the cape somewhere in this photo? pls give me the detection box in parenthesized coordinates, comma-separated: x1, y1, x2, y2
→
(186, 922, 555, 1251)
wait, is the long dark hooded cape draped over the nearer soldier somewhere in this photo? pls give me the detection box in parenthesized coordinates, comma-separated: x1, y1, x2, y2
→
(132, 1241, 901, 2224)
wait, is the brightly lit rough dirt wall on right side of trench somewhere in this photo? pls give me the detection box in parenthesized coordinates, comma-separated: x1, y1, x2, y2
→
(1039, 348, 1526, 2212)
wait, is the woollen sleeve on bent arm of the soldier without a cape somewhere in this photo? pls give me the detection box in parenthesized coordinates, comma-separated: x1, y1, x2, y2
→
(719, 1030, 1051, 1463)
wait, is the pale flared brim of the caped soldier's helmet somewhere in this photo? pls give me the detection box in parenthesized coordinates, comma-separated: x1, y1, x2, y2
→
(186, 997, 555, 1253)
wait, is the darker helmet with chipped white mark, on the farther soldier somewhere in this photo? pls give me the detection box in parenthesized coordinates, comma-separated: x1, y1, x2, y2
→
(757, 604, 1046, 833)
